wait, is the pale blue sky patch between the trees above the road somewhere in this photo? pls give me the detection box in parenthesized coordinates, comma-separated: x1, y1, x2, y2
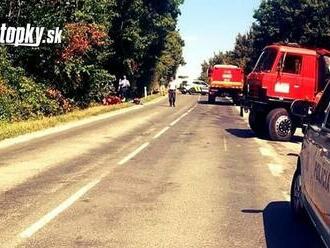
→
(178, 0, 261, 78)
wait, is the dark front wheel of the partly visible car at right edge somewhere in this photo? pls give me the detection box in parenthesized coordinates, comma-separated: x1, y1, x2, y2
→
(290, 168, 306, 221)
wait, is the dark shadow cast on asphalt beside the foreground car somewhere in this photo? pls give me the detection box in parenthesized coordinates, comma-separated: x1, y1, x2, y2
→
(242, 202, 324, 248)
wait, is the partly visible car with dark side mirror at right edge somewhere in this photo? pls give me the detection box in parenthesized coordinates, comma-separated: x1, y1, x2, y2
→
(291, 84, 330, 247)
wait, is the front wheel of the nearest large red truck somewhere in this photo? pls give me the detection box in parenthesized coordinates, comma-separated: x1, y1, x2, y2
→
(266, 108, 295, 141)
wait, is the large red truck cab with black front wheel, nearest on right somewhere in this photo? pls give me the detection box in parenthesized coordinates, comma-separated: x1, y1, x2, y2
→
(241, 44, 330, 141)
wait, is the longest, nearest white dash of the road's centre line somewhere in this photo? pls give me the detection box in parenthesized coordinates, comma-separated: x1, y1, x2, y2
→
(19, 179, 101, 239)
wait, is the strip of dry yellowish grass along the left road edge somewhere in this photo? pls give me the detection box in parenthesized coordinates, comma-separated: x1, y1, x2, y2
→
(0, 95, 161, 141)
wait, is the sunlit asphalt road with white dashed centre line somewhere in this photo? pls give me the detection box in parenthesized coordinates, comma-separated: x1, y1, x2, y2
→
(0, 96, 322, 248)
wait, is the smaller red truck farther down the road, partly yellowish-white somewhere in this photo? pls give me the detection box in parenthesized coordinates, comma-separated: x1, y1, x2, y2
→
(208, 65, 244, 104)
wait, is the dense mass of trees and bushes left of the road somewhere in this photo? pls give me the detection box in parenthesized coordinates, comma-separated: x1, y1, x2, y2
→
(0, 0, 184, 120)
